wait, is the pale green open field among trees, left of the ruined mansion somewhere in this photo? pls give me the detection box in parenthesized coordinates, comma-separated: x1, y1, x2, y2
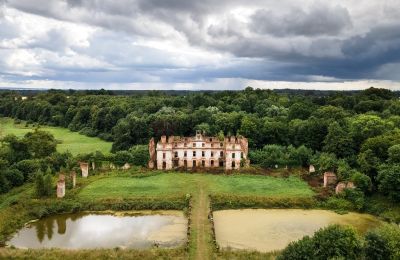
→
(0, 118, 112, 155)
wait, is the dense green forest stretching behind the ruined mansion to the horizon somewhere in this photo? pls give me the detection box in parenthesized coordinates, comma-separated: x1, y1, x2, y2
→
(0, 87, 400, 201)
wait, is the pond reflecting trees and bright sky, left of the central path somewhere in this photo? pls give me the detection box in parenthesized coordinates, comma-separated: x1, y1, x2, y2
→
(8, 211, 187, 249)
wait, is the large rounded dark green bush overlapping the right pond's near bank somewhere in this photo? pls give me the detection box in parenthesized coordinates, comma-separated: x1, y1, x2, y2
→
(278, 225, 363, 260)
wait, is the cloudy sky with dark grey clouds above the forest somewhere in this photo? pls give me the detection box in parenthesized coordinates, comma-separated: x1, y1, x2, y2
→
(0, 0, 400, 90)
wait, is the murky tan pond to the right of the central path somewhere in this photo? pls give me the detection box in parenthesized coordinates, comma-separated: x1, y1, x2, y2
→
(213, 209, 381, 252)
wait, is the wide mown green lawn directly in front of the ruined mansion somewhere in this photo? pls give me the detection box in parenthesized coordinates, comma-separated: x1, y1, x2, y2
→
(79, 173, 314, 199)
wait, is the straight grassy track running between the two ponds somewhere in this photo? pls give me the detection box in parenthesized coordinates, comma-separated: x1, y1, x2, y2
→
(189, 182, 213, 260)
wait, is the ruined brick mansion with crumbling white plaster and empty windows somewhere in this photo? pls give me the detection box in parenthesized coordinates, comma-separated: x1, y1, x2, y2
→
(149, 131, 249, 170)
